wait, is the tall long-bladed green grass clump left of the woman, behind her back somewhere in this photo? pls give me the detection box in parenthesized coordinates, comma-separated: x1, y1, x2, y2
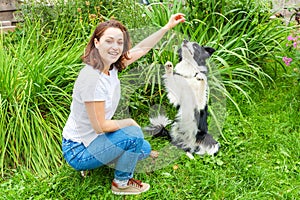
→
(0, 15, 83, 176)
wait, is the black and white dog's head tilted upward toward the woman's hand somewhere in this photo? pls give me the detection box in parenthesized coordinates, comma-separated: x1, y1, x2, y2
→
(178, 40, 215, 66)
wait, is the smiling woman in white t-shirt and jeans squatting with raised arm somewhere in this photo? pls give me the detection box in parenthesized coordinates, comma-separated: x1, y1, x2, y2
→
(62, 13, 185, 195)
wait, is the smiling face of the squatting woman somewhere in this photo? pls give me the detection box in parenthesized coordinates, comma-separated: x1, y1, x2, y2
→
(94, 27, 124, 67)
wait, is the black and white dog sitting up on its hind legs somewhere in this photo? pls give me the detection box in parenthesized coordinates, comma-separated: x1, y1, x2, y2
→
(147, 40, 220, 158)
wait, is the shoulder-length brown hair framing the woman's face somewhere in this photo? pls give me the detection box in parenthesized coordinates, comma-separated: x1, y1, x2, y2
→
(82, 19, 131, 71)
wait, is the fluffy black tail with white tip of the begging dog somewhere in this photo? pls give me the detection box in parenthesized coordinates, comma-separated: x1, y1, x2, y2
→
(144, 115, 172, 141)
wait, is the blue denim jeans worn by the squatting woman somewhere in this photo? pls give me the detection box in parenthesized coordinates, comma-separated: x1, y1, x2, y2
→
(62, 126, 151, 180)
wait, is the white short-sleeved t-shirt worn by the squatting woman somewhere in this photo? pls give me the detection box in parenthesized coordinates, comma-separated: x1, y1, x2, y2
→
(63, 65, 121, 146)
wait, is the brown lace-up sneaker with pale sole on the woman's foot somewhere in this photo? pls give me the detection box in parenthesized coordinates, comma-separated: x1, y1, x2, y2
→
(111, 178, 150, 195)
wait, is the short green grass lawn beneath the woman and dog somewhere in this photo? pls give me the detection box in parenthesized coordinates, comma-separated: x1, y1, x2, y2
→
(0, 74, 300, 199)
